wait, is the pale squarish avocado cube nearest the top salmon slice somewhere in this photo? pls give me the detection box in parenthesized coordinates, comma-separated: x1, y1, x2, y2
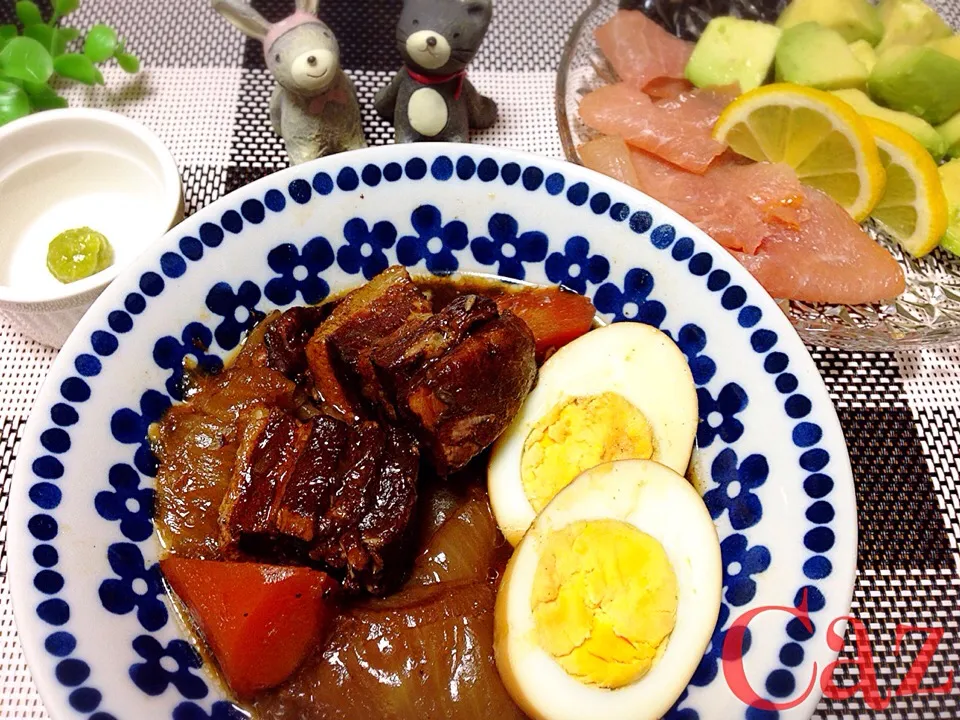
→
(685, 16, 780, 92)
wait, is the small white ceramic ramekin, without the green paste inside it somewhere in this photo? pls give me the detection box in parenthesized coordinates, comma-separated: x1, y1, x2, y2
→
(0, 109, 183, 347)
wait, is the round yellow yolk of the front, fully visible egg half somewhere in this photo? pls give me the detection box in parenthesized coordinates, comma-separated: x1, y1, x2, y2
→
(530, 520, 677, 689)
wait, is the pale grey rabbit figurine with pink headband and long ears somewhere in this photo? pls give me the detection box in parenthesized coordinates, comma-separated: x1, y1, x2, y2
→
(212, 0, 367, 165)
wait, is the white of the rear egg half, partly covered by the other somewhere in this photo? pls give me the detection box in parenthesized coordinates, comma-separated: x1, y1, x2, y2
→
(487, 322, 698, 545)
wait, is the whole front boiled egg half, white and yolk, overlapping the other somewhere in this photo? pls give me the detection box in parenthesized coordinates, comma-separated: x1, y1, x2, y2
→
(494, 460, 722, 720)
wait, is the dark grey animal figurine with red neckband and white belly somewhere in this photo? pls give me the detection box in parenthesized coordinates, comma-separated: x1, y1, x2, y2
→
(375, 0, 497, 143)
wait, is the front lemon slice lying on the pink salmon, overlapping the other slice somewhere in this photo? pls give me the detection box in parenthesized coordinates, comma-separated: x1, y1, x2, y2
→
(713, 83, 885, 222)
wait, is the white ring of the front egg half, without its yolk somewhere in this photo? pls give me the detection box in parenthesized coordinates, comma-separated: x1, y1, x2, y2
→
(494, 460, 722, 720)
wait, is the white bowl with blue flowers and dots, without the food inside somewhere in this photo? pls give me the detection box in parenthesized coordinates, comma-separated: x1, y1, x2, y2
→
(9, 145, 857, 720)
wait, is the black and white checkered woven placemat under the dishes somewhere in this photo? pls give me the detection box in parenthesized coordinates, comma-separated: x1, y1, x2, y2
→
(0, 0, 960, 720)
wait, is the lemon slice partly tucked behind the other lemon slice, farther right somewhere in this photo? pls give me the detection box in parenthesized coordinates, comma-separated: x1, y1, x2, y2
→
(866, 118, 948, 257)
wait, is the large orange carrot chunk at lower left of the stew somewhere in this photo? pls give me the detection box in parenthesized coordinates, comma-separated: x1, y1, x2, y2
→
(160, 557, 337, 698)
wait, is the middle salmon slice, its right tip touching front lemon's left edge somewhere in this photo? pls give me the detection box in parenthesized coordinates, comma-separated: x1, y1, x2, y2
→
(580, 83, 737, 173)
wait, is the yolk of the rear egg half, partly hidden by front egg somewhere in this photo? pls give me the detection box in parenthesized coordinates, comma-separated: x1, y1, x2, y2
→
(520, 392, 654, 513)
